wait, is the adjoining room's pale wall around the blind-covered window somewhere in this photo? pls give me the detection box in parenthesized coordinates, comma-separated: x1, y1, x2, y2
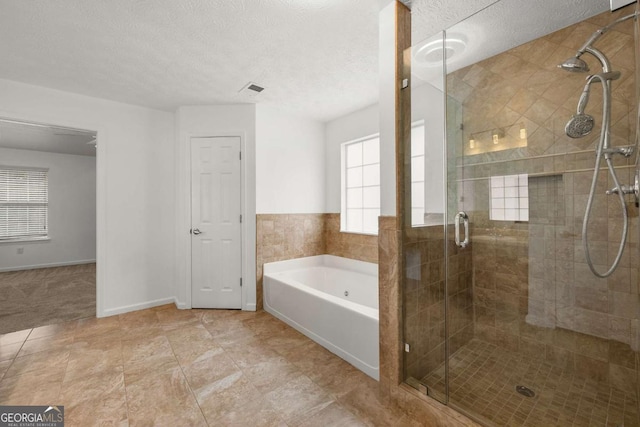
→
(0, 148, 96, 271)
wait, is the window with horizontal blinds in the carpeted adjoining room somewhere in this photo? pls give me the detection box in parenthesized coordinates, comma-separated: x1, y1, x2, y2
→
(0, 167, 49, 240)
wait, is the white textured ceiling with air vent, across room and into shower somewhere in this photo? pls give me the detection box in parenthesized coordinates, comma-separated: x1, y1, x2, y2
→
(0, 0, 608, 121)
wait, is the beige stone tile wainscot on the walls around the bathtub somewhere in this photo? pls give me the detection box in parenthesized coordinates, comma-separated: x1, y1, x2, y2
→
(256, 214, 378, 310)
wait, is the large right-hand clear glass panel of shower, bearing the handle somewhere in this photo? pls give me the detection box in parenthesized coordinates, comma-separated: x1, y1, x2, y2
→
(446, 0, 640, 426)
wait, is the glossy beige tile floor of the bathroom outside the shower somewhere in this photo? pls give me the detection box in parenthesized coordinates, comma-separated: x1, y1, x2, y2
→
(0, 305, 429, 427)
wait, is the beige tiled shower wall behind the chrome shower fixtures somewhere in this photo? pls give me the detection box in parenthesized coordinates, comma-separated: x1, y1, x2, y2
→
(448, 7, 640, 392)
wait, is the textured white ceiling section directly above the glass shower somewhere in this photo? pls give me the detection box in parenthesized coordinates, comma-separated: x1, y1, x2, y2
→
(411, 0, 609, 87)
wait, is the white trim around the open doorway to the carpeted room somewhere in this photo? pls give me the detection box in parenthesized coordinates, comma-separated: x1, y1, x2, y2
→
(0, 110, 108, 317)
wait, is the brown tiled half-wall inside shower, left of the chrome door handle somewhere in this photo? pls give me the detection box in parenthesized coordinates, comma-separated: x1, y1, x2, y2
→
(404, 225, 473, 382)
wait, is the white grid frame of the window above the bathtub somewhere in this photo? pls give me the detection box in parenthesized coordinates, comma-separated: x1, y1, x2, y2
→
(340, 133, 380, 236)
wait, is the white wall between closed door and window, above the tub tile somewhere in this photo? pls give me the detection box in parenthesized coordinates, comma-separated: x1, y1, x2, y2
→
(256, 105, 324, 214)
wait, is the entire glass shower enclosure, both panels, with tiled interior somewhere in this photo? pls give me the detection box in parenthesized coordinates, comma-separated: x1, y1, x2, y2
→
(403, 0, 640, 426)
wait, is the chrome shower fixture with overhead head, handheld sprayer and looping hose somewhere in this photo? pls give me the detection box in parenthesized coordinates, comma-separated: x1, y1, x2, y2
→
(558, 13, 639, 278)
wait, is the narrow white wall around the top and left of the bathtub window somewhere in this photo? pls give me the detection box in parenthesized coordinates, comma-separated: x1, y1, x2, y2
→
(325, 104, 380, 213)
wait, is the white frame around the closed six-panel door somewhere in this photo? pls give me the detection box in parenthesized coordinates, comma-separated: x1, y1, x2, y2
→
(176, 131, 256, 311)
